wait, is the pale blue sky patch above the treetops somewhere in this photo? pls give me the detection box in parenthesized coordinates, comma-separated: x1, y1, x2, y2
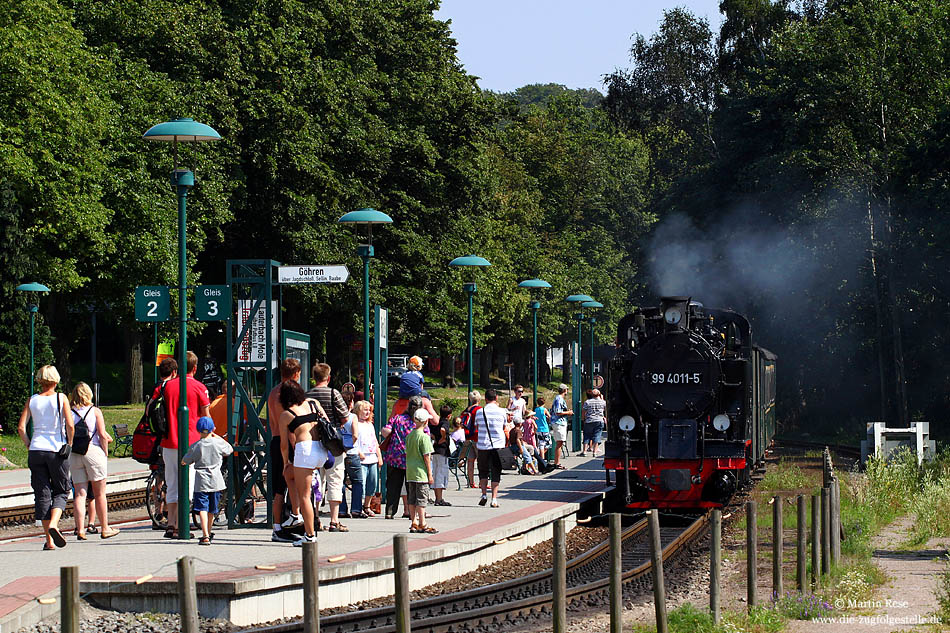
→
(435, 0, 721, 92)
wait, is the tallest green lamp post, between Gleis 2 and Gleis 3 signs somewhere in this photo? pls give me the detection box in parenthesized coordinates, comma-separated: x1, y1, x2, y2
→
(142, 118, 221, 540)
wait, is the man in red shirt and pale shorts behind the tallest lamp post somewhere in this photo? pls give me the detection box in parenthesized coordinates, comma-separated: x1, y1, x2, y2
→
(162, 352, 211, 538)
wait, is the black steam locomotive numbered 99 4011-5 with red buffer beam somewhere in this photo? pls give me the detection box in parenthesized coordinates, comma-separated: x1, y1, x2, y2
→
(604, 297, 776, 509)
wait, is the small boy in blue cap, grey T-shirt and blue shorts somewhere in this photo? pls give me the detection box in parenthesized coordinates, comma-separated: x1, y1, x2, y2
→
(181, 416, 234, 545)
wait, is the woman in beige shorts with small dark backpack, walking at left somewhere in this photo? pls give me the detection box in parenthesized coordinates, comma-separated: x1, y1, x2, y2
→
(69, 382, 119, 541)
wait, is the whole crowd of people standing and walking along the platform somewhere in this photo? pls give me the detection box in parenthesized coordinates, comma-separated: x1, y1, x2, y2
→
(18, 351, 605, 549)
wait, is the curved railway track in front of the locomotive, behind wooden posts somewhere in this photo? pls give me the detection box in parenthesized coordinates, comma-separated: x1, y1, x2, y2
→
(245, 515, 707, 633)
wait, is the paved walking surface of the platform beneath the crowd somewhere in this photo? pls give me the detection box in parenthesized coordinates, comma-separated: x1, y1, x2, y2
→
(0, 457, 605, 622)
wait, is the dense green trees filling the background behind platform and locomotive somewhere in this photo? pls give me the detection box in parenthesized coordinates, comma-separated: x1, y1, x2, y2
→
(0, 0, 950, 436)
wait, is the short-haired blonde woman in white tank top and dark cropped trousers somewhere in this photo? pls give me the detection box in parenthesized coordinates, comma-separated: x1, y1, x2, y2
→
(17, 365, 75, 550)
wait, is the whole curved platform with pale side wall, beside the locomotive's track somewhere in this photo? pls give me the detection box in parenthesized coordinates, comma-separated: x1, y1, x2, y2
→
(0, 458, 606, 631)
